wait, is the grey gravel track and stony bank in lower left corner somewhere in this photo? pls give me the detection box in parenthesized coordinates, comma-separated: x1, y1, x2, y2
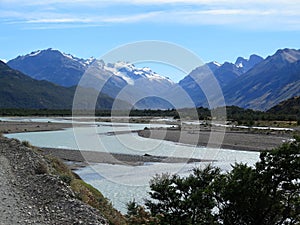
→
(0, 137, 109, 225)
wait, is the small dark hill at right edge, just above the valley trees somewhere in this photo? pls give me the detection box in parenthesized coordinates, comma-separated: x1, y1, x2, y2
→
(267, 96, 300, 118)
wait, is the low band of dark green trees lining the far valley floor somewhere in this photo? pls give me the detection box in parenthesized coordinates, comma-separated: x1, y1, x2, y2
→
(0, 103, 300, 127)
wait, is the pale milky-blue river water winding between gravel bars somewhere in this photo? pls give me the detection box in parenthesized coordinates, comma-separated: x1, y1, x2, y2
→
(0, 120, 276, 213)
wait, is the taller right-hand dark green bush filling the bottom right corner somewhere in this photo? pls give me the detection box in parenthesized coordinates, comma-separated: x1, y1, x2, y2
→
(215, 139, 300, 225)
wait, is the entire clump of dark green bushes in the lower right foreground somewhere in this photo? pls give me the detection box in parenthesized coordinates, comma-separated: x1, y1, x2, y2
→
(128, 137, 300, 225)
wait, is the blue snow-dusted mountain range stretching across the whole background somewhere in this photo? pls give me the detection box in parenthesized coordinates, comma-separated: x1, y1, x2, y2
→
(7, 49, 300, 110)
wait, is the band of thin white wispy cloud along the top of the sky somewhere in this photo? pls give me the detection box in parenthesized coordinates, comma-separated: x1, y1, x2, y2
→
(0, 0, 300, 30)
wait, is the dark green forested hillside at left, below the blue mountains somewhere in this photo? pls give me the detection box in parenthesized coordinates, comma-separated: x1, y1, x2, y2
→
(0, 61, 126, 109)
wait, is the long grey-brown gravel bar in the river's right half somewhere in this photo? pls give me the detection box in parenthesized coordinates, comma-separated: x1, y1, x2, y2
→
(138, 126, 293, 151)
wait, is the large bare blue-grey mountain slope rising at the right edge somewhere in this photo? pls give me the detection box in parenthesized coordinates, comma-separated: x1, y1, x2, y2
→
(223, 49, 300, 110)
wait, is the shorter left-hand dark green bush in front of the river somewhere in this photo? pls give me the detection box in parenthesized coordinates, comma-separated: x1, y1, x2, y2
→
(146, 166, 220, 225)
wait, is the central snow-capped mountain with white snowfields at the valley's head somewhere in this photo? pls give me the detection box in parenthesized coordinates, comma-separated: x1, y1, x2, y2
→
(80, 60, 176, 109)
